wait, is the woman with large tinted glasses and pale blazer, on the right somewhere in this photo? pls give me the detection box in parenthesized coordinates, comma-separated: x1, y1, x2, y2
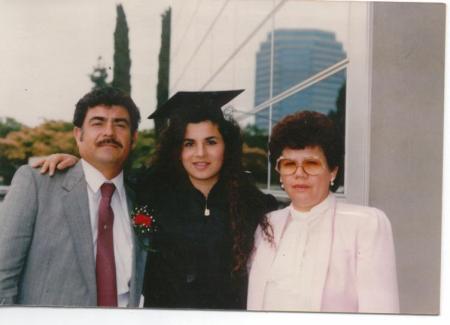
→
(247, 111, 399, 313)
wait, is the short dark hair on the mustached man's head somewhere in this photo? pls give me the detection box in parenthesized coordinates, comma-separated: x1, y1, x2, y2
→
(73, 87, 141, 133)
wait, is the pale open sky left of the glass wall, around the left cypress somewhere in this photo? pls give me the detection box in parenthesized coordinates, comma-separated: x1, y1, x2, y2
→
(0, 0, 170, 128)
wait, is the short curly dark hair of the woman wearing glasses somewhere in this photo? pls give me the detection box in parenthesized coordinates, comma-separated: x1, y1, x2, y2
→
(269, 111, 344, 190)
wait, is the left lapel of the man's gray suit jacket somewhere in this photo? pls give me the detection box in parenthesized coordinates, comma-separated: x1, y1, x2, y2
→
(62, 162, 97, 303)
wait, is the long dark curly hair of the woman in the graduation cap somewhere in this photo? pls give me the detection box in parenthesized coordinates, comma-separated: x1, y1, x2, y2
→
(151, 107, 272, 274)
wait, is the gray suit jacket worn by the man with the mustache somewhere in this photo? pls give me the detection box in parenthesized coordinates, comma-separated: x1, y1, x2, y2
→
(0, 162, 146, 307)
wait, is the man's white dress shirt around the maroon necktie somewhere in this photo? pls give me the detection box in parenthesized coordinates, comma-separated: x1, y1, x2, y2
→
(81, 159, 133, 307)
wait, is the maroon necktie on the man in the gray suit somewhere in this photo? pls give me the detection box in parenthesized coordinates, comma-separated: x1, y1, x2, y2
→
(95, 183, 117, 307)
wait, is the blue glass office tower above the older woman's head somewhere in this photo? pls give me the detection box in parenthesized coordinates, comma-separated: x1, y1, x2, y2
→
(254, 29, 346, 131)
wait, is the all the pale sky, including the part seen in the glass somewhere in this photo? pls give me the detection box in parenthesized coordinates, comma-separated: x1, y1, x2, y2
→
(0, 0, 347, 129)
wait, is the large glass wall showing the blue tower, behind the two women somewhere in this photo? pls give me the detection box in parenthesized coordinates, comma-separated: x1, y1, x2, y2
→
(170, 0, 355, 196)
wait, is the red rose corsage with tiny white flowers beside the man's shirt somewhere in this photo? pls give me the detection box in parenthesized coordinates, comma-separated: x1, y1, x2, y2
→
(131, 205, 158, 252)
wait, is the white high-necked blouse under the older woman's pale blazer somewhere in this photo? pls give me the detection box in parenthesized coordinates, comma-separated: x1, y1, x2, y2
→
(264, 194, 330, 311)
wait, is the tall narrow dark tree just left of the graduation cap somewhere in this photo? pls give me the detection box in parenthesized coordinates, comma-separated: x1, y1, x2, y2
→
(155, 7, 172, 137)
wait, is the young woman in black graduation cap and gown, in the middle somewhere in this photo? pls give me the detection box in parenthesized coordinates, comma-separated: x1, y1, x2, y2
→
(137, 91, 276, 309)
